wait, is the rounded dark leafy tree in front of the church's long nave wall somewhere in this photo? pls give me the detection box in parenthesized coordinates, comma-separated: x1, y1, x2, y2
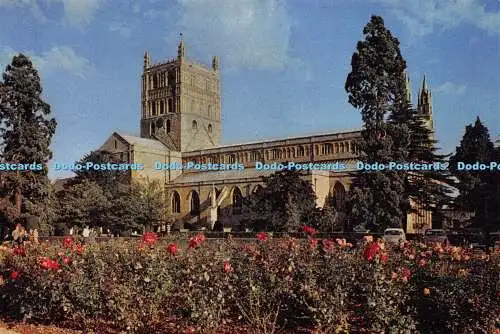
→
(244, 170, 316, 232)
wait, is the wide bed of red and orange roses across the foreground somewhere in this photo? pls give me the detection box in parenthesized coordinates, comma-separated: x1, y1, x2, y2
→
(0, 232, 500, 333)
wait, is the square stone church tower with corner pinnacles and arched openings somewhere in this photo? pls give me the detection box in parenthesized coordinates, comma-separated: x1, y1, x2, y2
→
(141, 34, 221, 152)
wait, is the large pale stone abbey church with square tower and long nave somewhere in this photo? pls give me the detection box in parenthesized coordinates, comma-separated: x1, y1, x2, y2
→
(98, 39, 433, 233)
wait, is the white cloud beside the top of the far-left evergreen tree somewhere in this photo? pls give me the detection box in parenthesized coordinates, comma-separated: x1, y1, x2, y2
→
(0, 46, 93, 78)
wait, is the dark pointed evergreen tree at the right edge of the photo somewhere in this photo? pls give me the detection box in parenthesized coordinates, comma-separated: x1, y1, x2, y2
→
(450, 117, 499, 229)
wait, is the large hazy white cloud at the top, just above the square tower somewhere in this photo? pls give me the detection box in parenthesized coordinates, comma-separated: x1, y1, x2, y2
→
(178, 0, 298, 69)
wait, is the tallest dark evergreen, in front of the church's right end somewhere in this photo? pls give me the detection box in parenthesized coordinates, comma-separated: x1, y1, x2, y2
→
(345, 16, 409, 230)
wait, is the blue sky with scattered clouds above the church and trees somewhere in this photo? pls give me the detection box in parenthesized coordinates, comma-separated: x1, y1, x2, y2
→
(0, 0, 500, 178)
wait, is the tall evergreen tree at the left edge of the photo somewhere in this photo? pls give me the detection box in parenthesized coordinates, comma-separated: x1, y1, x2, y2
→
(0, 54, 57, 228)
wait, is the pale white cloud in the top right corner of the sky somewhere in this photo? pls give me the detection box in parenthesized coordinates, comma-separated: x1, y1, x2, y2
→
(372, 0, 500, 35)
